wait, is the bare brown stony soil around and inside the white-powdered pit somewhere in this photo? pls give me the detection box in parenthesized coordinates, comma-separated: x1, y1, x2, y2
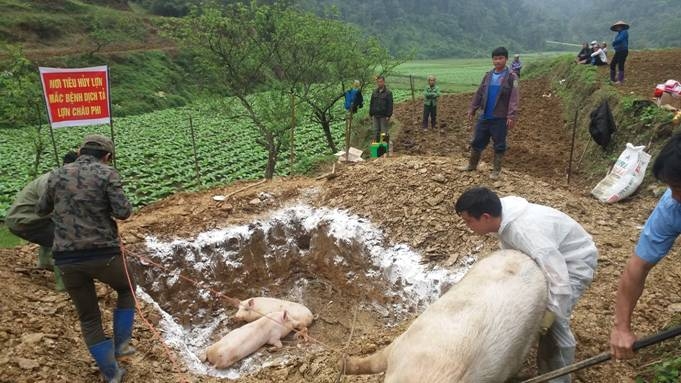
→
(0, 50, 681, 383)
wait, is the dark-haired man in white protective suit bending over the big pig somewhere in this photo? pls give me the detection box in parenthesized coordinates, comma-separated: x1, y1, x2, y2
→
(455, 187, 598, 383)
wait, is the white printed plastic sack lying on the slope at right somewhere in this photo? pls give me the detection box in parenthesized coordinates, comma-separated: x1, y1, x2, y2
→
(591, 143, 650, 203)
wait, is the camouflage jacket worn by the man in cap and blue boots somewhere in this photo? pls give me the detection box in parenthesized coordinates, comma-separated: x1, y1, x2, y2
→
(37, 155, 132, 254)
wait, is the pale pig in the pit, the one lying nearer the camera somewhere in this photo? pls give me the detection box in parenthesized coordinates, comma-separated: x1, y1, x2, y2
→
(201, 311, 293, 369)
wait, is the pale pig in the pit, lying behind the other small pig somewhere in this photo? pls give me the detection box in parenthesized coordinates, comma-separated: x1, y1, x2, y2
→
(234, 297, 313, 330)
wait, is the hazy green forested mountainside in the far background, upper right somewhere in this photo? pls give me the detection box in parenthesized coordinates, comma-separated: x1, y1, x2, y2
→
(129, 0, 681, 59)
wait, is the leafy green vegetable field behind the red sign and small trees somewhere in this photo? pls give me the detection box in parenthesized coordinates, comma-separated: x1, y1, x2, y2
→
(0, 90, 408, 218)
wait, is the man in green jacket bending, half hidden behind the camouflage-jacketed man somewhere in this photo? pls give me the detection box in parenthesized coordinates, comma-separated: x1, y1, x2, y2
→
(5, 152, 77, 291)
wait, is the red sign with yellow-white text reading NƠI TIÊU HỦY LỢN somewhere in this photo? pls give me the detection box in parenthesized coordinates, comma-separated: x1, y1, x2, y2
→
(40, 66, 111, 128)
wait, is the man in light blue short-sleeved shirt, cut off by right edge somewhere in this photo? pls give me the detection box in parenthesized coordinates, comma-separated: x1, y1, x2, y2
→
(610, 134, 681, 359)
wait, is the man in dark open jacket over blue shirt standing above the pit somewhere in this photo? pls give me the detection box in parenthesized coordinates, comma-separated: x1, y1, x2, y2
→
(462, 47, 519, 179)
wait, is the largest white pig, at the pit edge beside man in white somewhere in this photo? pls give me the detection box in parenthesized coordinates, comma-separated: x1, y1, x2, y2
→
(345, 250, 548, 383)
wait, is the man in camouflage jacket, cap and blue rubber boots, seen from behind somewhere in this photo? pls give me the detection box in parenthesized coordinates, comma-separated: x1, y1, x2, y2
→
(37, 134, 135, 383)
